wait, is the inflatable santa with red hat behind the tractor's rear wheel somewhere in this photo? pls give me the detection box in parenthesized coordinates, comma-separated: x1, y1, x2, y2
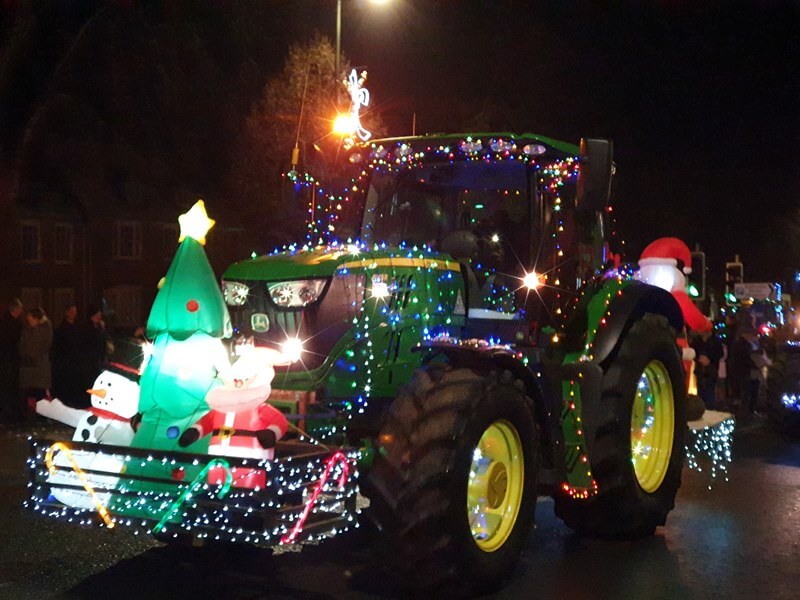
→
(637, 237, 712, 387)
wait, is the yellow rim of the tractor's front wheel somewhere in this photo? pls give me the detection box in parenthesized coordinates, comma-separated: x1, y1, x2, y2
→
(467, 420, 525, 552)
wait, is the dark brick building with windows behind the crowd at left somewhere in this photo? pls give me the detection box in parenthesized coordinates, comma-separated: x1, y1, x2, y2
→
(0, 162, 250, 328)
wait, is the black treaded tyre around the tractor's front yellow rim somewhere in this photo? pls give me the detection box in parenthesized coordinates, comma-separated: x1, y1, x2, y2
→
(365, 364, 535, 597)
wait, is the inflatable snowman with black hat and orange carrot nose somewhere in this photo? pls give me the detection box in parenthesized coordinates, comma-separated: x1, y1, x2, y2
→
(36, 367, 139, 510)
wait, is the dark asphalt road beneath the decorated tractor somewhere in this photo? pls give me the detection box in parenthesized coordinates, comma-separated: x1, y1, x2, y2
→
(0, 422, 800, 600)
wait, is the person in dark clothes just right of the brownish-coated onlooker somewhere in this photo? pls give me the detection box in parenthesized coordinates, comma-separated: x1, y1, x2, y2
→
(52, 304, 86, 408)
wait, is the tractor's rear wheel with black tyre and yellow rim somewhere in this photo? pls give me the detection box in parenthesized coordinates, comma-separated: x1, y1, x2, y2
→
(555, 314, 686, 538)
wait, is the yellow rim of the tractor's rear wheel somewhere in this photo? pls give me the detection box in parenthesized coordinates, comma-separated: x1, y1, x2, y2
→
(631, 360, 675, 494)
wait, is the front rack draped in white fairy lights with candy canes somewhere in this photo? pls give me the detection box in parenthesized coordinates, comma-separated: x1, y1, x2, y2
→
(25, 438, 360, 547)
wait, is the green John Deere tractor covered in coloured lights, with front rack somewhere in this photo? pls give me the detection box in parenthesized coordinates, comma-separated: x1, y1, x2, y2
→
(30, 133, 686, 595)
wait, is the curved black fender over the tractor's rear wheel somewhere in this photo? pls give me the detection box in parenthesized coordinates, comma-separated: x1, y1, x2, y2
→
(592, 281, 684, 364)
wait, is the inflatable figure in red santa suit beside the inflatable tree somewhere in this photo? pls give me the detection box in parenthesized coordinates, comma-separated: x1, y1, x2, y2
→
(178, 347, 288, 488)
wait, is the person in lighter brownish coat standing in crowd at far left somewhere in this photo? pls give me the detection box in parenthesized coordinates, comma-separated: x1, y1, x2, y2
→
(17, 308, 53, 421)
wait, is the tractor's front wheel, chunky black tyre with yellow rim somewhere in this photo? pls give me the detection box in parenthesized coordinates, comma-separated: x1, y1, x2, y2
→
(366, 365, 538, 597)
